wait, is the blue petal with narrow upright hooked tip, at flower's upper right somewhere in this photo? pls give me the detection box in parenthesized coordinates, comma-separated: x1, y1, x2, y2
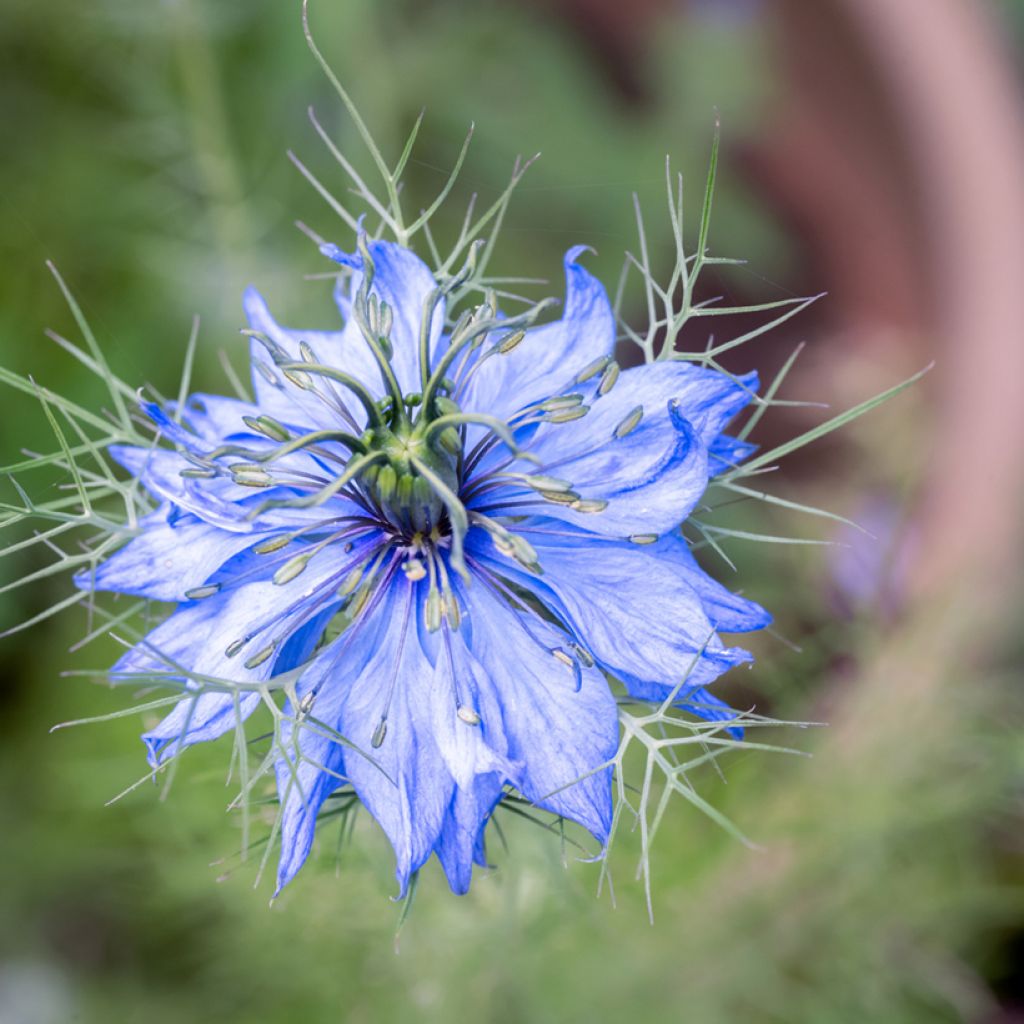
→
(462, 246, 615, 419)
